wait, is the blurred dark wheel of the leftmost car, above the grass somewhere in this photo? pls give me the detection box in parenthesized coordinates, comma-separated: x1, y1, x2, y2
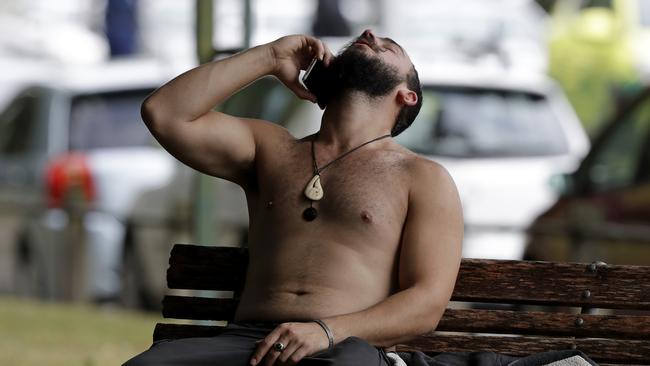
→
(13, 234, 47, 298)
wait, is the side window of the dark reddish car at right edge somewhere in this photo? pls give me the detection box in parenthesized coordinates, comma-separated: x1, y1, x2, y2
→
(585, 93, 650, 192)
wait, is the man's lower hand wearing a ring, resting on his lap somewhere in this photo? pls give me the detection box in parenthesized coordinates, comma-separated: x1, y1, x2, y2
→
(251, 322, 329, 366)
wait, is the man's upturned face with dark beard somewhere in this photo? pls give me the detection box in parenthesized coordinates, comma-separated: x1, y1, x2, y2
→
(332, 30, 411, 97)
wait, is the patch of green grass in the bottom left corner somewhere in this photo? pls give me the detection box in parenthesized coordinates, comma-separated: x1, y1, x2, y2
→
(0, 297, 161, 366)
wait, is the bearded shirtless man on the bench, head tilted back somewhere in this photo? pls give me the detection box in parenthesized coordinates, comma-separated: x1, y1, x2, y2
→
(127, 30, 463, 366)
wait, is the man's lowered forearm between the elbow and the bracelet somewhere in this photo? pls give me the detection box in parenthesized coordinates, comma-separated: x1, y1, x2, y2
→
(323, 286, 448, 347)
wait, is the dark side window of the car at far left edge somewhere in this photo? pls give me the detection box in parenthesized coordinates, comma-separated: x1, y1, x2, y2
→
(0, 92, 38, 155)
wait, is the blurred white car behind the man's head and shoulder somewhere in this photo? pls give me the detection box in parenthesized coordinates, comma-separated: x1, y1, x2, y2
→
(397, 66, 589, 259)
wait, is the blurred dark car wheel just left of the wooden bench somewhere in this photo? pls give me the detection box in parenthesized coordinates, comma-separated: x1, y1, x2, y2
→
(120, 226, 160, 310)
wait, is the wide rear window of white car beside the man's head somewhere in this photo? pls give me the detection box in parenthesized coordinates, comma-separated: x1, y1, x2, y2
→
(397, 88, 568, 157)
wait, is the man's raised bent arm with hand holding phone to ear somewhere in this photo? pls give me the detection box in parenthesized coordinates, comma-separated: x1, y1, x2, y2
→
(142, 36, 331, 185)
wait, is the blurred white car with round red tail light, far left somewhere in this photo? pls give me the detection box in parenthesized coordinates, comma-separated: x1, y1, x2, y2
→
(0, 60, 187, 300)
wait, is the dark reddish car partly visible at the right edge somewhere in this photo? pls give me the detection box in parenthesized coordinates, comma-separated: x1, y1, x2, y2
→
(525, 88, 650, 265)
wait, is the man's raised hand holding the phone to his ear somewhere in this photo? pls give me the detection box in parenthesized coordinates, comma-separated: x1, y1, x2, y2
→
(269, 35, 334, 103)
